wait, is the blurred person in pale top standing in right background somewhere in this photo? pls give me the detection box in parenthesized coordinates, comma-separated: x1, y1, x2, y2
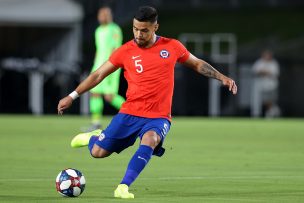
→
(253, 50, 280, 118)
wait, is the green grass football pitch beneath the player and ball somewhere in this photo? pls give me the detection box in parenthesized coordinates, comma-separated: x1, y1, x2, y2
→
(0, 115, 304, 203)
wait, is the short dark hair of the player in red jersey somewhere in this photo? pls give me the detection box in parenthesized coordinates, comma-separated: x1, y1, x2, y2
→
(134, 6, 158, 23)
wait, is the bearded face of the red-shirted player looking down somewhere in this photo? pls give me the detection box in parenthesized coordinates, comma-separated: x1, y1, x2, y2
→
(133, 19, 158, 47)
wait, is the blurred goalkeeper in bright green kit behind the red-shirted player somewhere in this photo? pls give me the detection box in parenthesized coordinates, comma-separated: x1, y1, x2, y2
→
(87, 7, 125, 131)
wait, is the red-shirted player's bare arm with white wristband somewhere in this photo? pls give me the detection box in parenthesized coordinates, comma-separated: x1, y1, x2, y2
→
(57, 61, 118, 114)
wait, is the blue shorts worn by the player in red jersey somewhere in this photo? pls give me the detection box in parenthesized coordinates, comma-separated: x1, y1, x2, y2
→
(95, 113, 171, 156)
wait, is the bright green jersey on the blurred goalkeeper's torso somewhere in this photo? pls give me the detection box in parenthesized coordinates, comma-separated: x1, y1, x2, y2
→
(92, 22, 122, 71)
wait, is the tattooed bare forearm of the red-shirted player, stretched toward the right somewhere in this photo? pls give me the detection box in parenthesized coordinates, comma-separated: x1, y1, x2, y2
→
(183, 54, 237, 94)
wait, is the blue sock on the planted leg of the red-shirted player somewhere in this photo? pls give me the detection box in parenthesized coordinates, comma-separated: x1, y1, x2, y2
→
(121, 145, 153, 186)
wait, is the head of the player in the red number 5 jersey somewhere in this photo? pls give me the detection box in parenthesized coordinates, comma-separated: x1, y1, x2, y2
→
(133, 6, 158, 47)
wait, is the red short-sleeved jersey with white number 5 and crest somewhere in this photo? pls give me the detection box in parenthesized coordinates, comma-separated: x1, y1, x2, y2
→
(109, 37, 190, 120)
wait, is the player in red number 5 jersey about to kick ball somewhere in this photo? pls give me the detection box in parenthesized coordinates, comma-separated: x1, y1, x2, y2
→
(58, 6, 237, 198)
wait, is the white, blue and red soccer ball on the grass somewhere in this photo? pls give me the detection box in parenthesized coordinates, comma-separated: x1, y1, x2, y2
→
(56, 168, 85, 197)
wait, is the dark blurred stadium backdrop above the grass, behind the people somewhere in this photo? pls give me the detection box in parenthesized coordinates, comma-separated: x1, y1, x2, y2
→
(0, 0, 304, 117)
